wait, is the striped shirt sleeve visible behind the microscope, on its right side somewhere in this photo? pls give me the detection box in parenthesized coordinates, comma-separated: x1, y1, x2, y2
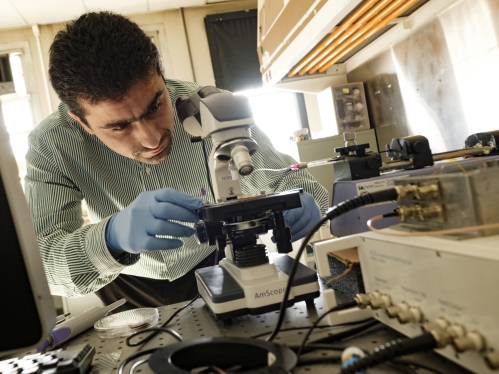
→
(241, 126, 329, 215)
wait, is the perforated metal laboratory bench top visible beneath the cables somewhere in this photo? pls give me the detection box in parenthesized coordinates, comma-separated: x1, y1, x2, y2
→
(23, 284, 469, 374)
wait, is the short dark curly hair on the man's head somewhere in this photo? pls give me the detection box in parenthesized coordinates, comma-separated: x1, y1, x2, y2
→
(49, 12, 163, 123)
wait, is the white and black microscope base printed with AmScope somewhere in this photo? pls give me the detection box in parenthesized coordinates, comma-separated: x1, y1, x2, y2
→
(196, 254, 320, 320)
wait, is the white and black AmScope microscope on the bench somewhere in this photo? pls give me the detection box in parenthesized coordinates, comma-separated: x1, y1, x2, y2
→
(175, 86, 319, 320)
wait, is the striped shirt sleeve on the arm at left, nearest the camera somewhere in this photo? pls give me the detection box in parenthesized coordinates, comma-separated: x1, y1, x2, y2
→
(25, 133, 139, 297)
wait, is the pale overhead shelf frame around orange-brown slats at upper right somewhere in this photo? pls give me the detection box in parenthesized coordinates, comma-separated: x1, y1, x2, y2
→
(259, 0, 457, 93)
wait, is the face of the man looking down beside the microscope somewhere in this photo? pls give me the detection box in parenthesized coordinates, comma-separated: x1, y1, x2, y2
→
(69, 74, 174, 164)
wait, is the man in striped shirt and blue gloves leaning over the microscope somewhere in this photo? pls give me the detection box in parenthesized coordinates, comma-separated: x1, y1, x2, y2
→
(25, 12, 327, 308)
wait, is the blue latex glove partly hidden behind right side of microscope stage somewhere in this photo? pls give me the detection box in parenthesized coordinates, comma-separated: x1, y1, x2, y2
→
(284, 192, 321, 242)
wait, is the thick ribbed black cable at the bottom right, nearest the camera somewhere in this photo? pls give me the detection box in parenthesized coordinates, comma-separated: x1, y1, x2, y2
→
(341, 332, 437, 374)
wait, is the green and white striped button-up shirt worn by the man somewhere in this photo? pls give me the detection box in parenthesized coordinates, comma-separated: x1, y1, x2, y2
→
(25, 80, 328, 297)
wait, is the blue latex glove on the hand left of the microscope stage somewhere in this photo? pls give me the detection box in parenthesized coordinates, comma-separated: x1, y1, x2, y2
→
(106, 188, 203, 253)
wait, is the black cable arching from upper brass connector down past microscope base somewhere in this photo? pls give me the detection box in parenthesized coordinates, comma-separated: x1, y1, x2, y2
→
(266, 188, 398, 342)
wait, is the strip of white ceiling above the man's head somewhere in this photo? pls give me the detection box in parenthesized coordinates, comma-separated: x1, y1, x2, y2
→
(0, 0, 235, 29)
